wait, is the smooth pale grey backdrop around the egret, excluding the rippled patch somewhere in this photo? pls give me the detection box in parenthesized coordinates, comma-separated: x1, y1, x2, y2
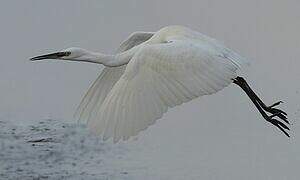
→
(0, 0, 300, 180)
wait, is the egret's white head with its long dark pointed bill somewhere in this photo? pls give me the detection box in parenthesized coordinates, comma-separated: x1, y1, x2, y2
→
(30, 47, 90, 61)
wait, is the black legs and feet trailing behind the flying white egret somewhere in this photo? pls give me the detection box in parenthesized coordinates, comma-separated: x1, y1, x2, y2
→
(233, 77, 290, 137)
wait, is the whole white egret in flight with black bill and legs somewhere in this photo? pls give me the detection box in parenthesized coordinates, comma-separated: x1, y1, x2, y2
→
(31, 26, 289, 142)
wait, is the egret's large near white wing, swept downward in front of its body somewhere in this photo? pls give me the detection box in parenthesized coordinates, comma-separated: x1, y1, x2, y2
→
(88, 40, 246, 142)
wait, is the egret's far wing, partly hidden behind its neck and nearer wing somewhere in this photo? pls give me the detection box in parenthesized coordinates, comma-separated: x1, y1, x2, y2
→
(75, 32, 153, 123)
